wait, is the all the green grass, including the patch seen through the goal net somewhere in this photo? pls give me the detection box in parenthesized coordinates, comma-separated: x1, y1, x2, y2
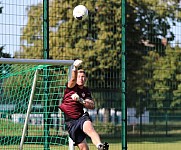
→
(0, 119, 181, 150)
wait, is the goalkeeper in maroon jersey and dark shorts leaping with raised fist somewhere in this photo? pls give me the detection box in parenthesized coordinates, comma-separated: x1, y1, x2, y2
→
(59, 60, 109, 150)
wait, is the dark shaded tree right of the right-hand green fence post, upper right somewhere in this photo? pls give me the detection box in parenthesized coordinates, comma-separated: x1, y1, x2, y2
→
(127, 0, 181, 106)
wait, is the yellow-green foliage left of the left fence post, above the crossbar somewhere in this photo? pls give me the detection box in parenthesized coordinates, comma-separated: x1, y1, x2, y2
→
(19, 4, 43, 58)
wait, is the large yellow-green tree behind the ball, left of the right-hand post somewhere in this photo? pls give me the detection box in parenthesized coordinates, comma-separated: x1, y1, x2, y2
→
(18, 0, 121, 112)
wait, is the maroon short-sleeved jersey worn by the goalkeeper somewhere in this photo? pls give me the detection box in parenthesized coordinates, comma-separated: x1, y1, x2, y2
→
(59, 84, 91, 119)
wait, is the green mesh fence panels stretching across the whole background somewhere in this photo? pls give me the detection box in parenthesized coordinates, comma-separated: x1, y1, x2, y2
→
(0, 0, 181, 150)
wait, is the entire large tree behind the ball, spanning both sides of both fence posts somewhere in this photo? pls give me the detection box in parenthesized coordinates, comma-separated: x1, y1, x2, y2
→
(18, 0, 181, 119)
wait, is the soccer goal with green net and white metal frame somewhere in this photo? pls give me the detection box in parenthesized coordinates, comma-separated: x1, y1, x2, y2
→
(0, 58, 73, 150)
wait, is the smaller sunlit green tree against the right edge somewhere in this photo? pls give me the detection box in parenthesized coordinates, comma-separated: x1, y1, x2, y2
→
(152, 46, 181, 109)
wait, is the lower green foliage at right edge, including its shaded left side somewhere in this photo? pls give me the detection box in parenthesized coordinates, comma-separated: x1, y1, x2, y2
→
(138, 46, 181, 109)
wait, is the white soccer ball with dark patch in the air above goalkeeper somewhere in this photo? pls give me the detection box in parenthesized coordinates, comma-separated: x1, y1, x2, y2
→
(73, 5, 88, 20)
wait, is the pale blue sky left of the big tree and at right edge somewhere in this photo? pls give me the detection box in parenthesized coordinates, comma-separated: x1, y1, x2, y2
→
(0, 0, 181, 56)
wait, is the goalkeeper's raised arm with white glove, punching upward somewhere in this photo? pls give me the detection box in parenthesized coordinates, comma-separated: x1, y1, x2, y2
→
(68, 60, 82, 88)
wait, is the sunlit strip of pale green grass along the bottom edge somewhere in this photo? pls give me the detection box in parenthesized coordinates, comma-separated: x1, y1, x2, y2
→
(0, 138, 181, 150)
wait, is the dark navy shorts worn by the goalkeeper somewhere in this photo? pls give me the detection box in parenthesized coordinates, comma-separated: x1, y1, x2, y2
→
(66, 112, 91, 145)
